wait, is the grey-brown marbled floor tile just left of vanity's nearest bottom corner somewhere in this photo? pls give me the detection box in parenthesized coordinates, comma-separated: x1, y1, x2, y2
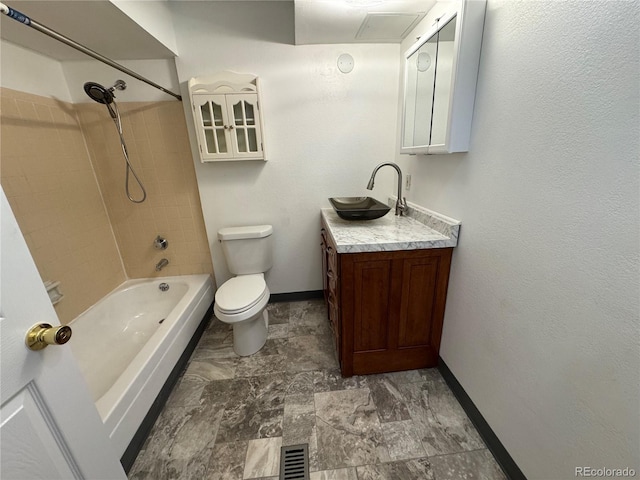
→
(287, 335, 338, 372)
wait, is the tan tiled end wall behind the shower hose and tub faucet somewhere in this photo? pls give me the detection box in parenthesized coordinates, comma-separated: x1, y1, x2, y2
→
(76, 102, 213, 278)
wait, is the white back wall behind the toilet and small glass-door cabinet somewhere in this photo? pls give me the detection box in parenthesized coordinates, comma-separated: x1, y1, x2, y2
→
(171, 2, 400, 293)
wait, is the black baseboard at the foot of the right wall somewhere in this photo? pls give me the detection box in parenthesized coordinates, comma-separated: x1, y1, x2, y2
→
(438, 357, 527, 480)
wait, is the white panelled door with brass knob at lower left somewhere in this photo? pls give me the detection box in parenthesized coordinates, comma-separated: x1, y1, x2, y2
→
(0, 189, 126, 480)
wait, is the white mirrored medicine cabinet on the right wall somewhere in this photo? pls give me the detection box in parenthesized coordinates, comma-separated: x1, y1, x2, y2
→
(400, 0, 486, 154)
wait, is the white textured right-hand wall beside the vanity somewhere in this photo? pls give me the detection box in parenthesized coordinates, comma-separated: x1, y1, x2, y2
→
(399, 0, 640, 479)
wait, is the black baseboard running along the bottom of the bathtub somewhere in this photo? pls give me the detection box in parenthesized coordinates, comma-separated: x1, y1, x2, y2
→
(120, 303, 213, 474)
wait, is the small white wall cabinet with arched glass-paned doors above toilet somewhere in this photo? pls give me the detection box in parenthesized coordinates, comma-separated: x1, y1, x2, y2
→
(189, 72, 266, 163)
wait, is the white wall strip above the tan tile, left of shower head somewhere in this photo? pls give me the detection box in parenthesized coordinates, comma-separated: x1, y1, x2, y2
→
(0, 40, 71, 102)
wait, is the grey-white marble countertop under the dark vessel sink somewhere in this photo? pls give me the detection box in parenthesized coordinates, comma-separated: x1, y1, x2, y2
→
(321, 199, 460, 253)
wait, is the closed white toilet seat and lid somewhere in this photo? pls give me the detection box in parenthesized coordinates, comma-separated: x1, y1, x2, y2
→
(214, 273, 270, 323)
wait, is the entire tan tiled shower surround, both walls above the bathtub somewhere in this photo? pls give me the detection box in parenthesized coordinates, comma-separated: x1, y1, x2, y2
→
(0, 88, 213, 323)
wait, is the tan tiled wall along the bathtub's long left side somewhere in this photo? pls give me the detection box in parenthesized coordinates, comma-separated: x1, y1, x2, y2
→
(0, 88, 125, 324)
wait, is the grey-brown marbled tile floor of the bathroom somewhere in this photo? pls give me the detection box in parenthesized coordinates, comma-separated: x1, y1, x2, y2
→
(129, 300, 506, 480)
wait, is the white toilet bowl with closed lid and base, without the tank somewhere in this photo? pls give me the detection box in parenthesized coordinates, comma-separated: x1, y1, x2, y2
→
(213, 273, 270, 356)
